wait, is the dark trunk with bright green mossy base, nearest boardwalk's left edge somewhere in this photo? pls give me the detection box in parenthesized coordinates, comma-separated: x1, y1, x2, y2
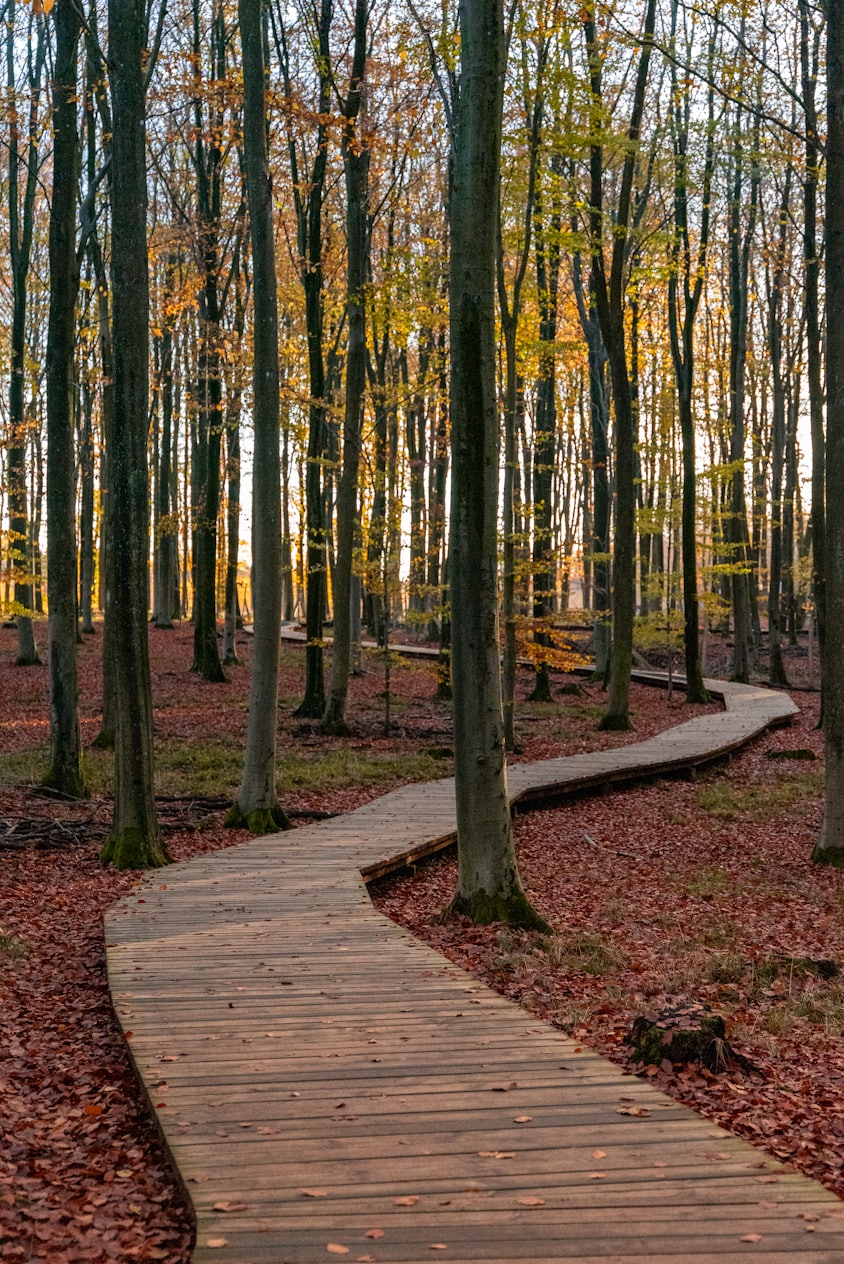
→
(102, 0, 169, 868)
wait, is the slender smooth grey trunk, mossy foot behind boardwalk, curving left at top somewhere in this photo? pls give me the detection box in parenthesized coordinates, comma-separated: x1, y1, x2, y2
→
(227, 0, 289, 834)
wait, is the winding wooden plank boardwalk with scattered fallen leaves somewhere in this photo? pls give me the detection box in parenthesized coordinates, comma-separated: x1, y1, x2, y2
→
(106, 681, 844, 1264)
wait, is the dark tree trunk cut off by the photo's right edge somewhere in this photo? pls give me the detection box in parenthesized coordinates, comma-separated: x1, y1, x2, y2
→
(812, 0, 844, 868)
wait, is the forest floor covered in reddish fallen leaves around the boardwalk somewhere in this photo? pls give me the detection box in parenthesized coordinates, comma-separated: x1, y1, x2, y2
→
(0, 616, 844, 1264)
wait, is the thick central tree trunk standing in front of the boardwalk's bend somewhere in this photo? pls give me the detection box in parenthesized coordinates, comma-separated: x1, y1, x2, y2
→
(450, 0, 545, 928)
